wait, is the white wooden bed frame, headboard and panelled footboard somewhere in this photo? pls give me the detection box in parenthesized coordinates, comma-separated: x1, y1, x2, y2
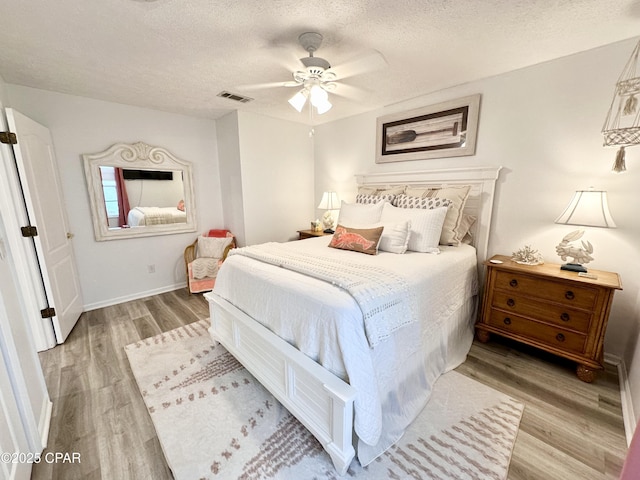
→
(205, 167, 501, 475)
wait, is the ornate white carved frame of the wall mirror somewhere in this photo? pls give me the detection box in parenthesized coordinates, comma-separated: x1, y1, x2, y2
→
(82, 142, 197, 242)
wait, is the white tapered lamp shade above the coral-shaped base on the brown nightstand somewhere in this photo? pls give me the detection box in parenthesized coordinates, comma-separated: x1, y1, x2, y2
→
(555, 190, 616, 228)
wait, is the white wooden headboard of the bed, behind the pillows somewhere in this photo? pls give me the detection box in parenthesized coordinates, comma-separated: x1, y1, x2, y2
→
(356, 167, 502, 263)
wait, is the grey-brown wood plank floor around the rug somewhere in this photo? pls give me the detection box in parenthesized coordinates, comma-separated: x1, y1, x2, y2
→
(31, 289, 626, 480)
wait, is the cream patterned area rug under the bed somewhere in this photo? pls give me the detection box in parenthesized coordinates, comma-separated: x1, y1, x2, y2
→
(125, 320, 524, 480)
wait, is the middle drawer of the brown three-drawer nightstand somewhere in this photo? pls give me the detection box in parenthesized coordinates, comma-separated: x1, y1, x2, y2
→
(491, 290, 591, 333)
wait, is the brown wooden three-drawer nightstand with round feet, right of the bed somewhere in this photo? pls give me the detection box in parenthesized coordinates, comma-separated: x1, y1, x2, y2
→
(476, 255, 622, 382)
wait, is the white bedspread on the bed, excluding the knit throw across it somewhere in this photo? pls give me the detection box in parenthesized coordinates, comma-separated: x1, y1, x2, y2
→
(213, 237, 477, 465)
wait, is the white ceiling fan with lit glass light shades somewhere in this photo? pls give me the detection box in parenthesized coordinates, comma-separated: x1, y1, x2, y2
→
(239, 32, 387, 114)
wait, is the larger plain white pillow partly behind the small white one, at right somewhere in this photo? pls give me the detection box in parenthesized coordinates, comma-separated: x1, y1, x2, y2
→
(380, 203, 447, 253)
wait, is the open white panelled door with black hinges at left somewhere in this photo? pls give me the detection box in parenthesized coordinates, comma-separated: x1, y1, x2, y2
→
(6, 108, 82, 343)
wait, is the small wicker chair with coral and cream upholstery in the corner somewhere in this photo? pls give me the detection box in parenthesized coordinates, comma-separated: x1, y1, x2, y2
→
(184, 230, 236, 293)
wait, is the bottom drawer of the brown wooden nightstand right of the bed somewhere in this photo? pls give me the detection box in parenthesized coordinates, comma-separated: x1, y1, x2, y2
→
(489, 310, 587, 353)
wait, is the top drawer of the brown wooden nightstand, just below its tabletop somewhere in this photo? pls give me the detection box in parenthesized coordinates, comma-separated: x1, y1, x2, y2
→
(495, 271, 598, 309)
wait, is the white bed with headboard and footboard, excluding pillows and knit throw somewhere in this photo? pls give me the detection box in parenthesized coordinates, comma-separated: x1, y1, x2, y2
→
(206, 167, 499, 474)
